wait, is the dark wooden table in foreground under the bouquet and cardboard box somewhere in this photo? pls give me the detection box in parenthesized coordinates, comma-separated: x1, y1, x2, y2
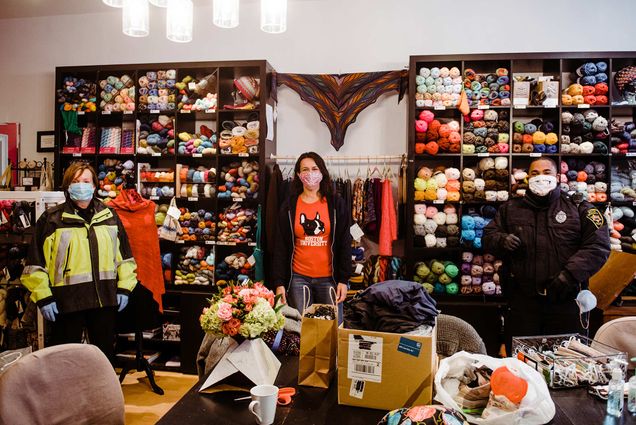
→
(157, 357, 636, 425)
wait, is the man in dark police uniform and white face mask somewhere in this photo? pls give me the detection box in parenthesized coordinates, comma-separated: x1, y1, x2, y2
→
(483, 158, 610, 344)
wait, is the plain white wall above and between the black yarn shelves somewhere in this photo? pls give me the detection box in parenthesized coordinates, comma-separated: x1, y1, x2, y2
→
(0, 0, 636, 162)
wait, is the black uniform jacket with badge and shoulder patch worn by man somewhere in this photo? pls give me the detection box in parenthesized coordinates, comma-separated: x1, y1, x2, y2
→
(483, 187, 610, 296)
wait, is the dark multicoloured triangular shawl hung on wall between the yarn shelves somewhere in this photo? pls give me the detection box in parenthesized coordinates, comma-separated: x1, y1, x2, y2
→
(272, 70, 408, 150)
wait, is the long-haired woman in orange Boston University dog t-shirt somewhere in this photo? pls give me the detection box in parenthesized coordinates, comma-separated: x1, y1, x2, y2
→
(273, 152, 351, 311)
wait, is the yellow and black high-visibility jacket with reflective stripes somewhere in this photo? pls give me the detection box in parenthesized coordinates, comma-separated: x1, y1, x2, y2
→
(20, 200, 137, 313)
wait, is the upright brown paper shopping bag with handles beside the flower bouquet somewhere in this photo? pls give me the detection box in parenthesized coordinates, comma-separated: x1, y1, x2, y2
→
(298, 287, 338, 388)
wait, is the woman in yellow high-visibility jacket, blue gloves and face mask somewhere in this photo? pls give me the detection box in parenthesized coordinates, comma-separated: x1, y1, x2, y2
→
(20, 162, 137, 360)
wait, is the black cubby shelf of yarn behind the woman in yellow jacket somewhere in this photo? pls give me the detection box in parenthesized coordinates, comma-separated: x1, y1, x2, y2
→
(55, 61, 276, 373)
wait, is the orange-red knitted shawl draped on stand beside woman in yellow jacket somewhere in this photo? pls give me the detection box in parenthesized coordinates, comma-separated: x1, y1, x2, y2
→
(108, 189, 166, 312)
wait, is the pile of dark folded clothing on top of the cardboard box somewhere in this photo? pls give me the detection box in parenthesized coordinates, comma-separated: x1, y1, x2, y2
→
(344, 280, 437, 333)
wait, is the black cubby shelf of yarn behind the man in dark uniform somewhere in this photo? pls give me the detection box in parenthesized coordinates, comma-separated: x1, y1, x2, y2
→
(405, 52, 636, 324)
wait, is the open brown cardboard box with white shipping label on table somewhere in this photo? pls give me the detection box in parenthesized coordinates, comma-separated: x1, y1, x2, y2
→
(338, 326, 437, 410)
